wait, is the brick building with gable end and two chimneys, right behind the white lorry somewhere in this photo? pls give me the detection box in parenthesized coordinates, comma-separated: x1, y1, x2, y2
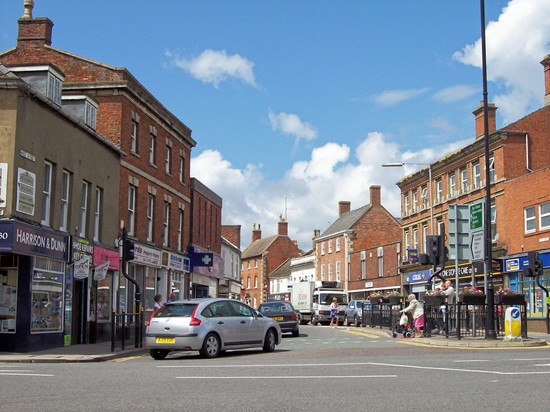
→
(314, 185, 401, 299)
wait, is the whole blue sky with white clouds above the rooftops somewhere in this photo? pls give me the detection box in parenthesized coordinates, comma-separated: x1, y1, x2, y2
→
(0, 0, 550, 251)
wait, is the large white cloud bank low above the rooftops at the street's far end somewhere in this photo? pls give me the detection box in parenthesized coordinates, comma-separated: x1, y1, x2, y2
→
(191, 132, 454, 249)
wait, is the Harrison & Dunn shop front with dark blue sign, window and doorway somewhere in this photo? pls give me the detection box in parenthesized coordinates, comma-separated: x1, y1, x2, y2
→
(0, 220, 71, 352)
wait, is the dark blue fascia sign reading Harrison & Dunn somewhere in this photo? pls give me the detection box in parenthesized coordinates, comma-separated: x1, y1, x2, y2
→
(0, 221, 69, 262)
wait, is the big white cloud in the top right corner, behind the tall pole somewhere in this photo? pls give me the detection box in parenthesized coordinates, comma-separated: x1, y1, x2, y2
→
(453, 0, 550, 124)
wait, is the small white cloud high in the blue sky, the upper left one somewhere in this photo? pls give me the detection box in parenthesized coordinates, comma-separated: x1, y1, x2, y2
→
(166, 49, 256, 87)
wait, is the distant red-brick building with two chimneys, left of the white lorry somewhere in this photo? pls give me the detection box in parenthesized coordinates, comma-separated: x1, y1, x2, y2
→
(241, 217, 301, 307)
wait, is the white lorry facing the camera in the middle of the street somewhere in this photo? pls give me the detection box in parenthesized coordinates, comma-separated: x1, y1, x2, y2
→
(290, 281, 348, 326)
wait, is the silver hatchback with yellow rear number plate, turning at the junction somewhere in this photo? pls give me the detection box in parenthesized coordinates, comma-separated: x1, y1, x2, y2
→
(145, 298, 282, 360)
